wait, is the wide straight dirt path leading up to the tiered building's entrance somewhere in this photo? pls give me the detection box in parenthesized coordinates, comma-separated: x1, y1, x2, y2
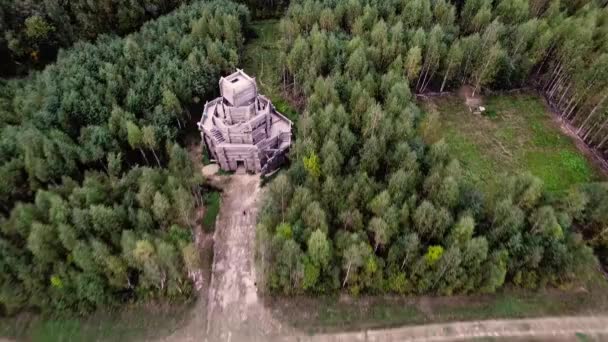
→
(201, 174, 287, 341)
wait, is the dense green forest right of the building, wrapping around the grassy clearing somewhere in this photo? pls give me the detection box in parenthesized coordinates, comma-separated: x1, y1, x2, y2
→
(257, 0, 608, 295)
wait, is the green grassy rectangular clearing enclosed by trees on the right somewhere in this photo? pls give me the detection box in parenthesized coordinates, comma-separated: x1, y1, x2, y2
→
(422, 94, 603, 192)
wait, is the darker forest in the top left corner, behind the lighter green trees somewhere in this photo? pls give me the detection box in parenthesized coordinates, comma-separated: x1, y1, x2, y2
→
(0, 0, 195, 75)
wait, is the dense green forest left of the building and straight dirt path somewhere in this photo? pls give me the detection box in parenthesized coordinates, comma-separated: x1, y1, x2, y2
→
(0, 1, 249, 313)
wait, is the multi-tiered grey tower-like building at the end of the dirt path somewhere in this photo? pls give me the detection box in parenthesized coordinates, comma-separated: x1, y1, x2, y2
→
(198, 69, 292, 174)
